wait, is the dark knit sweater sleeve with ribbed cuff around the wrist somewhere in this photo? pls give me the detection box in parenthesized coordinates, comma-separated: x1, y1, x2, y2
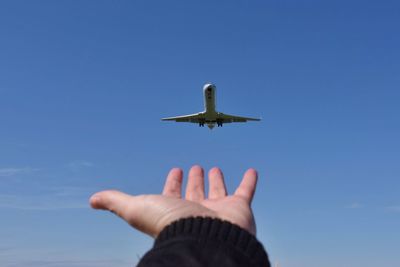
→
(138, 217, 270, 267)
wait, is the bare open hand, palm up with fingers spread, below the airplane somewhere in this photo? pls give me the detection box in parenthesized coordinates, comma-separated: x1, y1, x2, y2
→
(90, 166, 257, 237)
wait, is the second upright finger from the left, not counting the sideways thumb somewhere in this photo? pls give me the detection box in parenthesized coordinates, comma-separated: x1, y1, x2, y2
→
(186, 165, 204, 202)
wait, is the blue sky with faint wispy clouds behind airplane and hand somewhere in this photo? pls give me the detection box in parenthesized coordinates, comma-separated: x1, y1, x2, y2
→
(0, 0, 400, 267)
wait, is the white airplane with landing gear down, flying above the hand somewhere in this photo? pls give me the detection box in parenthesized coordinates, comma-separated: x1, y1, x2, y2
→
(162, 83, 260, 129)
